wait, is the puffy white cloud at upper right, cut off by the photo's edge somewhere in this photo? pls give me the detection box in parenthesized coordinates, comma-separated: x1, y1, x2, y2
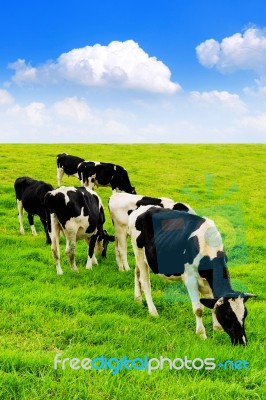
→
(196, 28, 266, 75)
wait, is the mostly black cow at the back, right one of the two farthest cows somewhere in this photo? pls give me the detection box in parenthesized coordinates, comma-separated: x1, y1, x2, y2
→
(78, 161, 136, 194)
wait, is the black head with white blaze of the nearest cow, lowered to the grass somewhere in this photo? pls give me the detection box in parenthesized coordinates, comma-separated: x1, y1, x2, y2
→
(200, 293, 256, 345)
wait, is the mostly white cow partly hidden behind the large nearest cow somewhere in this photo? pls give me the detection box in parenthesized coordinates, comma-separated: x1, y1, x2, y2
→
(108, 193, 195, 271)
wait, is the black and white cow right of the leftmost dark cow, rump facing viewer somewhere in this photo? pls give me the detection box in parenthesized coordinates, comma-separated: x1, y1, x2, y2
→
(45, 186, 114, 275)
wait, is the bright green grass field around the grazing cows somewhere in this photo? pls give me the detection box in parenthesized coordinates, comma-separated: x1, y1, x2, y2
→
(0, 144, 266, 400)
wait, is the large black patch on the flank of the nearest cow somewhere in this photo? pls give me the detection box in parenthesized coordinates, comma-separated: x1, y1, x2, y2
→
(136, 207, 205, 276)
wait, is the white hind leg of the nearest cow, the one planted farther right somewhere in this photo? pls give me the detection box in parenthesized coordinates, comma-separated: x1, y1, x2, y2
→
(136, 249, 158, 317)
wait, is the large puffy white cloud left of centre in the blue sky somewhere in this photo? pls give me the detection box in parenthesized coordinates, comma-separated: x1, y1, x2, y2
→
(9, 40, 181, 93)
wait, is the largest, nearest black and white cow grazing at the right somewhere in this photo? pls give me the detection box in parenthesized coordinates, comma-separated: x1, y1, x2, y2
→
(129, 206, 255, 345)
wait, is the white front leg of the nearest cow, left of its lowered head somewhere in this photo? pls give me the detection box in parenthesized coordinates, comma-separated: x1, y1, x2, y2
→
(182, 264, 207, 339)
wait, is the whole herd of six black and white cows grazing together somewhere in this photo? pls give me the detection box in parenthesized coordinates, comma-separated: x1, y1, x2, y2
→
(14, 153, 255, 345)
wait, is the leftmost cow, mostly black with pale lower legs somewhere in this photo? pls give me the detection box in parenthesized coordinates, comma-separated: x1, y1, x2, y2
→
(14, 176, 53, 243)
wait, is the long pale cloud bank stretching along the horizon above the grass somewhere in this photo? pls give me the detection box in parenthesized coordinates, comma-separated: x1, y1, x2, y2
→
(0, 91, 266, 143)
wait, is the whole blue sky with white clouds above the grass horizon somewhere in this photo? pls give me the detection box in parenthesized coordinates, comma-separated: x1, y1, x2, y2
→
(0, 0, 266, 143)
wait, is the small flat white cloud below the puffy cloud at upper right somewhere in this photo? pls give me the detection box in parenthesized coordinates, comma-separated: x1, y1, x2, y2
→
(190, 90, 246, 112)
